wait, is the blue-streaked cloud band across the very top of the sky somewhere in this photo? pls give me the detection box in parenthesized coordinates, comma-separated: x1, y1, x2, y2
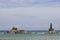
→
(0, 0, 60, 8)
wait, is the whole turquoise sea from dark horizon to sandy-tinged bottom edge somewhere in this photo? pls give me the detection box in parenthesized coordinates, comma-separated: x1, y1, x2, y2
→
(0, 30, 60, 40)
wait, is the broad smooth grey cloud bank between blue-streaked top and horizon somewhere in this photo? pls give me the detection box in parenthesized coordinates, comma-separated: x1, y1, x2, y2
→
(0, 7, 60, 30)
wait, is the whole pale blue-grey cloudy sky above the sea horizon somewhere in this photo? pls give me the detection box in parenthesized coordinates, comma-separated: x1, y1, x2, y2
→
(0, 0, 60, 30)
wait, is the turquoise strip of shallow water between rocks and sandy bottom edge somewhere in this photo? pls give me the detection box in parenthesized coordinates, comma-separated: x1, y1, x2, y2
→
(0, 32, 60, 38)
